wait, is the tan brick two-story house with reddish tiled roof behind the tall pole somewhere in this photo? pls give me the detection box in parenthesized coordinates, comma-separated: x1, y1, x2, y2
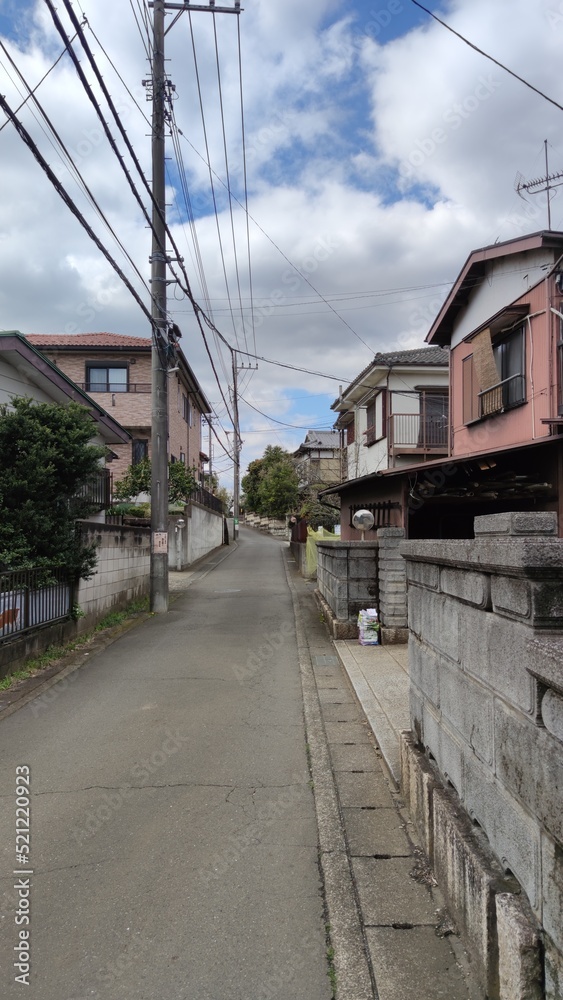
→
(27, 333, 211, 480)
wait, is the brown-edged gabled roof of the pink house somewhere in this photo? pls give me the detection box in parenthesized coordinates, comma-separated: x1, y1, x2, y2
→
(426, 230, 563, 345)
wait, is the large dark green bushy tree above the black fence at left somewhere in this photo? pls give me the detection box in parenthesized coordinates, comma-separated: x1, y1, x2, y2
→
(0, 398, 105, 577)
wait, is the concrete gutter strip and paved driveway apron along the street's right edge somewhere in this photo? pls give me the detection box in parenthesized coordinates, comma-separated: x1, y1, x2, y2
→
(287, 555, 482, 1000)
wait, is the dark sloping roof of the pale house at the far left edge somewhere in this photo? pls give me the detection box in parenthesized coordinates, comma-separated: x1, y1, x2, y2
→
(0, 330, 131, 444)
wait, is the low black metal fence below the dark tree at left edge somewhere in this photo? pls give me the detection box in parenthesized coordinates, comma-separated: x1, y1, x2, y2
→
(0, 566, 74, 643)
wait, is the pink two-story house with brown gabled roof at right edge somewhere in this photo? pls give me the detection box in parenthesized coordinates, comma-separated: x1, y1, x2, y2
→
(413, 231, 563, 536)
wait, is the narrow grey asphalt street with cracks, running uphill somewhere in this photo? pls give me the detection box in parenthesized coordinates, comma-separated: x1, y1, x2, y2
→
(0, 531, 331, 1000)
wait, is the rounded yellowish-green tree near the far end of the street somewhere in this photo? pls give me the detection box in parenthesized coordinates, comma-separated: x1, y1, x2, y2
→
(242, 445, 298, 518)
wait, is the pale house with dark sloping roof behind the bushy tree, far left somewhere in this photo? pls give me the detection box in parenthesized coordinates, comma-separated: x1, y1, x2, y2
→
(0, 330, 131, 509)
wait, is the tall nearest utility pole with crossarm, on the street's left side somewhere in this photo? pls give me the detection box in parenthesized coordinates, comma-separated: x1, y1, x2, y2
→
(149, 0, 241, 614)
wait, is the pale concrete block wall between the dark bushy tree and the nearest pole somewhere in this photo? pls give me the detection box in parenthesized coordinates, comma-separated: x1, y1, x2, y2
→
(77, 522, 150, 628)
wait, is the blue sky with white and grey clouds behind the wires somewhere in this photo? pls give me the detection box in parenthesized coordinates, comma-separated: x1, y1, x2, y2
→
(0, 0, 563, 484)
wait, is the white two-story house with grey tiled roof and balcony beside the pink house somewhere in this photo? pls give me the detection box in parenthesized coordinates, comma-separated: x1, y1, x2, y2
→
(331, 347, 449, 480)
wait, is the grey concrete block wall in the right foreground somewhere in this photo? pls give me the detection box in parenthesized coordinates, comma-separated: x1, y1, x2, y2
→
(401, 513, 563, 1000)
